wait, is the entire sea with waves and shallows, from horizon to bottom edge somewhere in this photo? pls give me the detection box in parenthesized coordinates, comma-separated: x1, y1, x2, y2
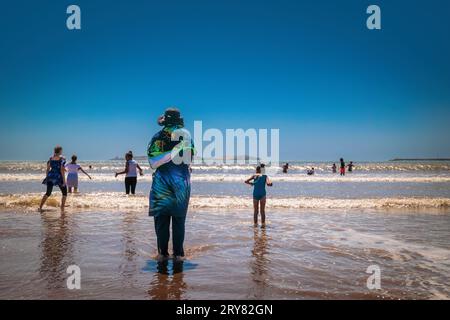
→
(0, 160, 450, 299)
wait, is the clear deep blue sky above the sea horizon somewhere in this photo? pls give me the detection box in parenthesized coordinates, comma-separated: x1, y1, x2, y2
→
(0, 0, 450, 160)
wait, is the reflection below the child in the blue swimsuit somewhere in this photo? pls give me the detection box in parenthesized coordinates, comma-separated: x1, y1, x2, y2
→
(250, 227, 270, 299)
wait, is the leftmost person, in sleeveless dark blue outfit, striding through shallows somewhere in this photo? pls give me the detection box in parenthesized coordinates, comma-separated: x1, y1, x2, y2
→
(38, 146, 67, 213)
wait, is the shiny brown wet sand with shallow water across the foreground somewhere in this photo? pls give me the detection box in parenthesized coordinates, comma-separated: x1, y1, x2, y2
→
(0, 208, 450, 299)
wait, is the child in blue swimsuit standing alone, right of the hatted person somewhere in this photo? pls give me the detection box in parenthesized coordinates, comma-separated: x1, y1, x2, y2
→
(245, 165, 273, 227)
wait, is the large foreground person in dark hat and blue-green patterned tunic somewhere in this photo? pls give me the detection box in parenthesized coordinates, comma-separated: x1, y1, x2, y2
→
(147, 108, 194, 263)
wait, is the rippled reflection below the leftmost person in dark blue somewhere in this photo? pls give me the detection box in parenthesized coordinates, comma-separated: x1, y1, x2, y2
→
(39, 213, 73, 289)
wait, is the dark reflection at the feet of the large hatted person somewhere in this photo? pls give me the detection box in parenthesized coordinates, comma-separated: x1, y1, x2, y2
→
(148, 261, 187, 300)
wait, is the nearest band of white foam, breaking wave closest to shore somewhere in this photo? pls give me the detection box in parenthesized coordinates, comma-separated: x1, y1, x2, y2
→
(0, 192, 450, 212)
